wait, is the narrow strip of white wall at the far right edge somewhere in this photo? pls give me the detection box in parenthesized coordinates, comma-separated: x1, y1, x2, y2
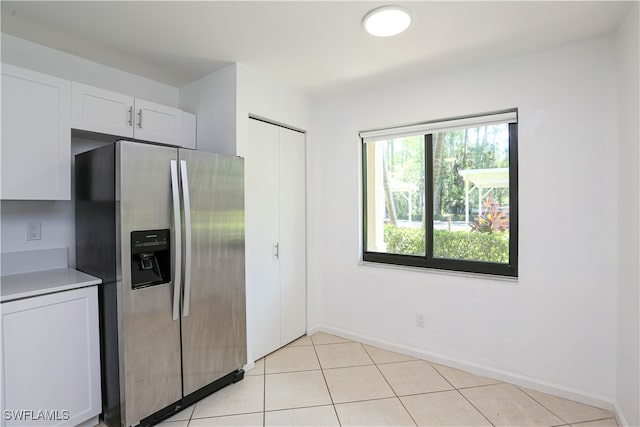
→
(616, 2, 640, 426)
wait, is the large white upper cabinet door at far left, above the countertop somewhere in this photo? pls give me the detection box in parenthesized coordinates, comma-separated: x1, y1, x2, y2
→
(1, 64, 71, 200)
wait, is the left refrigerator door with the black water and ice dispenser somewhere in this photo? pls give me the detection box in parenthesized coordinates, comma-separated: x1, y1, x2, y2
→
(116, 141, 182, 426)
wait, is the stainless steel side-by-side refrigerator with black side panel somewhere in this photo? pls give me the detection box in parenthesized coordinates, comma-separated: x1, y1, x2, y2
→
(75, 141, 247, 427)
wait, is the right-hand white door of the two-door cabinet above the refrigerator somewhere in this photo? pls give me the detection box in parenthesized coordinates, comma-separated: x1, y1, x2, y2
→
(133, 99, 182, 145)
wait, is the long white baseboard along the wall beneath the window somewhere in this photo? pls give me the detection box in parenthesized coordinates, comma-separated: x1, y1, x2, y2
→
(308, 325, 616, 414)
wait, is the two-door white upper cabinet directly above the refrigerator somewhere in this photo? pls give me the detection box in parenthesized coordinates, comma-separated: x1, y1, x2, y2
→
(71, 82, 196, 148)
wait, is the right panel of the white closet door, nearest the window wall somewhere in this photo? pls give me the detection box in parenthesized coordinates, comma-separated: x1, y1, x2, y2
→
(280, 128, 307, 345)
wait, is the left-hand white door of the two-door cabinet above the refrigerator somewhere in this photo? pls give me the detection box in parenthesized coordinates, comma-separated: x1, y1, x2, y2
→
(71, 82, 133, 138)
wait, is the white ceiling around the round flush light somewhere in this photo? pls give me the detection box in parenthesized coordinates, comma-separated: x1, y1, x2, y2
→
(1, 0, 630, 97)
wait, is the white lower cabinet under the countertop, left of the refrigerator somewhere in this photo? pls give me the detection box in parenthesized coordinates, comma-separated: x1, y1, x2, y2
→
(1, 286, 101, 426)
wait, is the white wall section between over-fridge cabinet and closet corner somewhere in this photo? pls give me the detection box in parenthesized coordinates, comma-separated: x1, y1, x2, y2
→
(180, 64, 237, 155)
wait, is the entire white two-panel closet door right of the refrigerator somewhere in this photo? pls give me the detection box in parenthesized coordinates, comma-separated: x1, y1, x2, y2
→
(245, 119, 307, 360)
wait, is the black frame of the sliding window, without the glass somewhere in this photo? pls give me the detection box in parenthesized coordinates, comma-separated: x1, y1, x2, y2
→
(361, 118, 518, 277)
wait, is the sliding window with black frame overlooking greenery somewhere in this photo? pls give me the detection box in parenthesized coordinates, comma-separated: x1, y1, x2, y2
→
(360, 110, 518, 276)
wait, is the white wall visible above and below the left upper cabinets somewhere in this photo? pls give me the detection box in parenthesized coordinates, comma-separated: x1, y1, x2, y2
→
(0, 34, 178, 267)
